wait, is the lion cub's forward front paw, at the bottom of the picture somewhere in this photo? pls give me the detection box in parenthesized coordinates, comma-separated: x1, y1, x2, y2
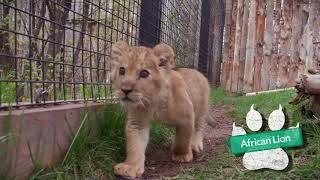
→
(114, 163, 144, 177)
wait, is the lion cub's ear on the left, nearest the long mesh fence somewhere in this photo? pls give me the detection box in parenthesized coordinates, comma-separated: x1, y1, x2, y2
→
(111, 41, 129, 65)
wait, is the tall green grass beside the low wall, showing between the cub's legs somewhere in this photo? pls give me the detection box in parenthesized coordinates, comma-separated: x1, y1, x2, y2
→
(31, 104, 172, 179)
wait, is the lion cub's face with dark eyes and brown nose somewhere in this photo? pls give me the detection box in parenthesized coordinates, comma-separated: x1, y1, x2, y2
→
(111, 42, 174, 106)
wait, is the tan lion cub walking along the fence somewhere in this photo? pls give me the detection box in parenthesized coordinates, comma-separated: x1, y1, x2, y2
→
(111, 41, 209, 177)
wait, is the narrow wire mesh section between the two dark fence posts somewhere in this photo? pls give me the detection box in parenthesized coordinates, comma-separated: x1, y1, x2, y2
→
(161, 0, 201, 68)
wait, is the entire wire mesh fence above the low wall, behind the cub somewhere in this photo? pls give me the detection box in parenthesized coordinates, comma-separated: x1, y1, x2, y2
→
(0, 0, 210, 109)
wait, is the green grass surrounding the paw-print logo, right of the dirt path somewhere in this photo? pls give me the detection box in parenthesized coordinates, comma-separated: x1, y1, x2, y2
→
(178, 88, 320, 179)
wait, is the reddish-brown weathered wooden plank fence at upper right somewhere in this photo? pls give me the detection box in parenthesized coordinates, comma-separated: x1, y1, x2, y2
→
(221, 0, 320, 93)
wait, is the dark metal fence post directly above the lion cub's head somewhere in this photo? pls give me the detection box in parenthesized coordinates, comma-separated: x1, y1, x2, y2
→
(139, 0, 161, 47)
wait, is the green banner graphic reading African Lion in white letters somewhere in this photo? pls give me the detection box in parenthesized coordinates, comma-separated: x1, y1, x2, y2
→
(229, 128, 303, 155)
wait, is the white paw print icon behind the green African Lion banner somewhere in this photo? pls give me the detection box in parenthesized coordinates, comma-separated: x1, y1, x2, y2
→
(232, 105, 289, 170)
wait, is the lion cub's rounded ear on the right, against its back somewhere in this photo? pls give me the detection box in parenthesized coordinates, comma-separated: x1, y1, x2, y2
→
(153, 43, 175, 69)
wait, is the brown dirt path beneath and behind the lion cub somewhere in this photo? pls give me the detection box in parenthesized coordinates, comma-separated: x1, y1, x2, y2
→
(118, 106, 232, 179)
